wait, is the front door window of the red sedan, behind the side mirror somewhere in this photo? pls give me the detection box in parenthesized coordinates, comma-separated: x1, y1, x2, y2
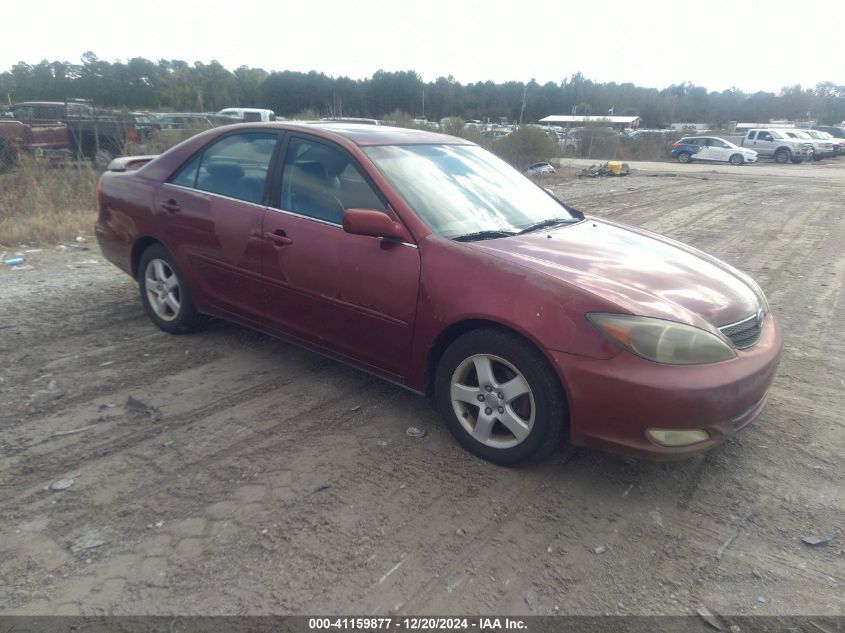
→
(280, 138, 387, 224)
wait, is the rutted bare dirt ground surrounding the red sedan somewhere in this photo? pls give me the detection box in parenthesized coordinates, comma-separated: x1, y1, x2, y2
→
(0, 158, 845, 616)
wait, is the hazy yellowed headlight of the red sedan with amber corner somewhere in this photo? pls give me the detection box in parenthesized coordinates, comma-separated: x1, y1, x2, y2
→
(587, 312, 736, 365)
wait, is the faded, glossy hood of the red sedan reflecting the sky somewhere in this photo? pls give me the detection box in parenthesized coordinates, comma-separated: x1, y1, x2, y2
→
(467, 217, 761, 328)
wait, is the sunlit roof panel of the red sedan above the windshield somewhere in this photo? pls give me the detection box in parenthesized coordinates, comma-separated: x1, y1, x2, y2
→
(270, 121, 474, 147)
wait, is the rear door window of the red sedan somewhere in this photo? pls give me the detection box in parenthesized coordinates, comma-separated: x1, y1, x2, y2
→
(169, 133, 277, 204)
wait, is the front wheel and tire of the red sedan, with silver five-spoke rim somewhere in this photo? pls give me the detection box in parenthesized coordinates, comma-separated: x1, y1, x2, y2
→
(435, 328, 567, 465)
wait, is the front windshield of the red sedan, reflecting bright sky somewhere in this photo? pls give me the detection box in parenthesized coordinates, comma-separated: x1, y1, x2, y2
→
(364, 145, 580, 238)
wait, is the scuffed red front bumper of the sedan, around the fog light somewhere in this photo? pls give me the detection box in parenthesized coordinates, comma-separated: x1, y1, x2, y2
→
(550, 314, 783, 459)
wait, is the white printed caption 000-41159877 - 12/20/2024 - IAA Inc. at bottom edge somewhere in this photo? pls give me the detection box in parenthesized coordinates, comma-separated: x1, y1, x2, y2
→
(308, 617, 528, 632)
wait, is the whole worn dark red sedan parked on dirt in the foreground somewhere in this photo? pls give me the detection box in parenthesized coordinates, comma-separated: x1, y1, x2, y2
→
(96, 123, 781, 464)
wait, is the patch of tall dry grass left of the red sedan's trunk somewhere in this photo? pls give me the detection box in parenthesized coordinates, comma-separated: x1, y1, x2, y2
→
(0, 156, 99, 245)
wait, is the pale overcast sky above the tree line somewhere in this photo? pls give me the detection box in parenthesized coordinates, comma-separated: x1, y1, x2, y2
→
(0, 0, 845, 92)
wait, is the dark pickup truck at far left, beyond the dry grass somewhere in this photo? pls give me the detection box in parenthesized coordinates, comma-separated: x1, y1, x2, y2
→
(11, 100, 137, 167)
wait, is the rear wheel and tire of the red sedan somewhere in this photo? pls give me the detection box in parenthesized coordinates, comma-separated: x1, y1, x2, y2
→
(138, 244, 205, 334)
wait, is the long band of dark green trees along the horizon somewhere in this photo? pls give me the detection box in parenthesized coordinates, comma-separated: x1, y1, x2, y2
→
(0, 51, 845, 127)
